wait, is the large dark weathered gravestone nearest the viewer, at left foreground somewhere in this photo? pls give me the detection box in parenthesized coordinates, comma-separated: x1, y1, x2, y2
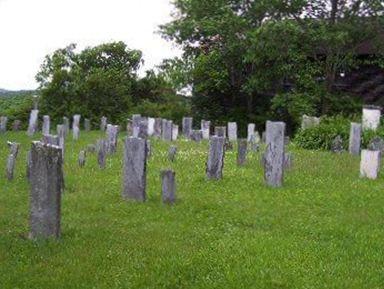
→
(29, 142, 64, 239)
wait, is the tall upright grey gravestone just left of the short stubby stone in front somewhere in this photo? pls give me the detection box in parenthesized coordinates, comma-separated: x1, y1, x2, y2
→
(122, 137, 147, 201)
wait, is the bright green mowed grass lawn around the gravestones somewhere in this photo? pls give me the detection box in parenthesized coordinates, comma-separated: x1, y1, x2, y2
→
(0, 132, 384, 289)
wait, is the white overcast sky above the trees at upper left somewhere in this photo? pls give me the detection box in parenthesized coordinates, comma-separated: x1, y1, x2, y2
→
(0, 0, 180, 90)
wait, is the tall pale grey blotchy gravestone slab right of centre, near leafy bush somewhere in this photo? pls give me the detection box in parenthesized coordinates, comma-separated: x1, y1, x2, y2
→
(263, 121, 285, 187)
